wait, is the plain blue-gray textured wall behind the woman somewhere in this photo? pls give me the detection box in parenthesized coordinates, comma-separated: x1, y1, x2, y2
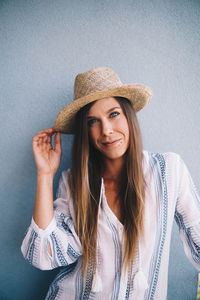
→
(0, 0, 200, 300)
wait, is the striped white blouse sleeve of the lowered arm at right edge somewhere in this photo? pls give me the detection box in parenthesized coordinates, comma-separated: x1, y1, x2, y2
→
(175, 156, 200, 271)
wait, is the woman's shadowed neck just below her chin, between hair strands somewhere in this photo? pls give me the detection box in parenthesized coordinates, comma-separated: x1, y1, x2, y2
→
(103, 157, 125, 181)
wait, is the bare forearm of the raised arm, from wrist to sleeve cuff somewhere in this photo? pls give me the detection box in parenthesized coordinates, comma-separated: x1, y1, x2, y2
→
(33, 174, 54, 229)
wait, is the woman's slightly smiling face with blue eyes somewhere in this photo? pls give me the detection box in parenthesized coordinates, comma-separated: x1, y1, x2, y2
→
(88, 97, 129, 160)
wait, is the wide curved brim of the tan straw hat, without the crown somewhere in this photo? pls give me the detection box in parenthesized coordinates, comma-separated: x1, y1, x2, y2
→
(53, 83, 152, 134)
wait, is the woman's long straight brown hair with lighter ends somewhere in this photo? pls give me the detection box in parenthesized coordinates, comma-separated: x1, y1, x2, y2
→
(72, 97, 146, 273)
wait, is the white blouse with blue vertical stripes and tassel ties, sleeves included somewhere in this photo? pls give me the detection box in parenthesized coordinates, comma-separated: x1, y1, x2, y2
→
(21, 151, 200, 300)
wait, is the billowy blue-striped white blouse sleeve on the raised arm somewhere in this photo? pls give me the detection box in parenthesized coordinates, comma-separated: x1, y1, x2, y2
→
(21, 170, 82, 270)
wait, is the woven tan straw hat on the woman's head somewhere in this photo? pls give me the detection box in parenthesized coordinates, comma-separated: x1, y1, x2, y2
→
(54, 67, 152, 134)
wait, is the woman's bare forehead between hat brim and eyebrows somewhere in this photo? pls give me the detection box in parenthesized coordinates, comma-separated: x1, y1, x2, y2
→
(89, 97, 120, 114)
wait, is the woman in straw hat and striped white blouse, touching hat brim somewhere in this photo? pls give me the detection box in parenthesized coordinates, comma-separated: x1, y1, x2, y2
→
(22, 68, 200, 300)
